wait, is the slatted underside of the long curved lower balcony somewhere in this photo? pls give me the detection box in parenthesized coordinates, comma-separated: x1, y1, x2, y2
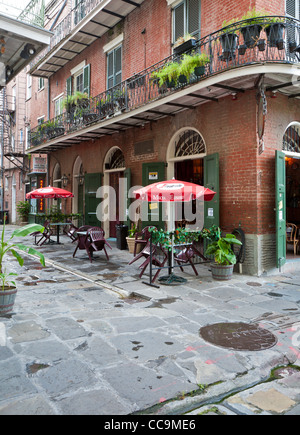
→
(30, 69, 300, 153)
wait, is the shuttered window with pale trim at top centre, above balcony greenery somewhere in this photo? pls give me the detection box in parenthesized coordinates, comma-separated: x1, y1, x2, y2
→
(173, 0, 201, 43)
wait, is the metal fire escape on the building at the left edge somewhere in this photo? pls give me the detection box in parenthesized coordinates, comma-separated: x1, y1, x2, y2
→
(0, 87, 28, 172)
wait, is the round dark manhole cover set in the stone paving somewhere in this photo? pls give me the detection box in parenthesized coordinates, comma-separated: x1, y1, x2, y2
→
(199, 323, 277, 351)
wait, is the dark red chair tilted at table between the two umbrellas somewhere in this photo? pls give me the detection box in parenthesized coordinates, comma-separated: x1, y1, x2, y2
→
(73, 226, 112, 262)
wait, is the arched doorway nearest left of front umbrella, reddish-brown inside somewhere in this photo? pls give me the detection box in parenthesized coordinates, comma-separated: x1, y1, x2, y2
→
(103, 147, 126, 237)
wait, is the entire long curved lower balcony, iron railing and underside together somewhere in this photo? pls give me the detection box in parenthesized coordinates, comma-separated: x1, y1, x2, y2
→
(27, 18, 300, 153)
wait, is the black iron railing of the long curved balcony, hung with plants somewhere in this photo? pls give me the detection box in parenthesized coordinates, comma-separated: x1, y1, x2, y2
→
(31, 16, 300, 147)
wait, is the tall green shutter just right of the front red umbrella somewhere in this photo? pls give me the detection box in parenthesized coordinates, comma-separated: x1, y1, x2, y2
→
(204, 153, 219, 228)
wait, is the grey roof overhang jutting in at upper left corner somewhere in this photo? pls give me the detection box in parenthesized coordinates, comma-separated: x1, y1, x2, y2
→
(0, 14, 52, 88)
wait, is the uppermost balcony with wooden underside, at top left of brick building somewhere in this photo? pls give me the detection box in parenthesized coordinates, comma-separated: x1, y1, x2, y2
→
(30, 0, 144, 78)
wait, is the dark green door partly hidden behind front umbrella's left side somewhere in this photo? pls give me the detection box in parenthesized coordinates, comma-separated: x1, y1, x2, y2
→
(142, 162, 166, 228)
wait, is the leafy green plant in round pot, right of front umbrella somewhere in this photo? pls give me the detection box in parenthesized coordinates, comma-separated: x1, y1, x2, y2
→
(205, 228, 242, 281)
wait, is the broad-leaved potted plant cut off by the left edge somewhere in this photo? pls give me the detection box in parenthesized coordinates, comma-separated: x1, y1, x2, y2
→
(0, 220, 45, 316)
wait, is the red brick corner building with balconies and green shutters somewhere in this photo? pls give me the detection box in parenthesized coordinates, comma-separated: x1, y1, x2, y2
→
(22, 0, 300, 274)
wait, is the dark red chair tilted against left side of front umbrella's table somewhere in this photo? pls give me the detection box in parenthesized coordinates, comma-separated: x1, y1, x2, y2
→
(128, 239, 168, 283)
